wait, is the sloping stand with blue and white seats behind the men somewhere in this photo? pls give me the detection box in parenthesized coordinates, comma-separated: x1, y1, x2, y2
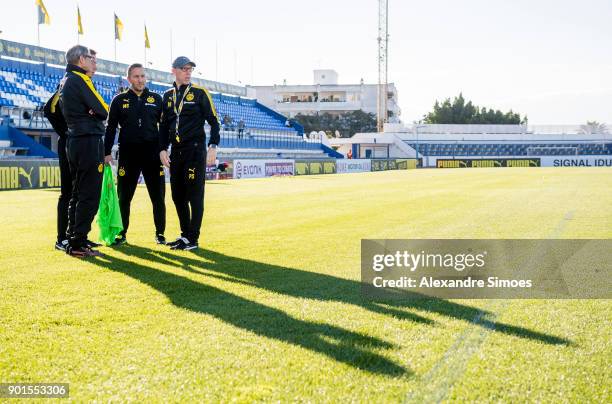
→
(0, 57, 340, 159)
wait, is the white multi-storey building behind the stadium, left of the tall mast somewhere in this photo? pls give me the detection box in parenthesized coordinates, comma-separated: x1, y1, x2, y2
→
(247, 70, 401, 122)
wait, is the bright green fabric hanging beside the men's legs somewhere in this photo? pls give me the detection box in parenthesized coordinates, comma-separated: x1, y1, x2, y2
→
(98, 164, 123, 246)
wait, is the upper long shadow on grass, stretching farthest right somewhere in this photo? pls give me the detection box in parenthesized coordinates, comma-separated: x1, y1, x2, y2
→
(126, 246, 572, 345)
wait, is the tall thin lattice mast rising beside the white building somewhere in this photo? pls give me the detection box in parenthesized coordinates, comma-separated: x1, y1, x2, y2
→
(376, 0, 389, 132)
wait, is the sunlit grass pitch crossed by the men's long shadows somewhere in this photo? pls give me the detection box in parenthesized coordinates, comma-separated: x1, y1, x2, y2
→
(0, 168, 612, 402)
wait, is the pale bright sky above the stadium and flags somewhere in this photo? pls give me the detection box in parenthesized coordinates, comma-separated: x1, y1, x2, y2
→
(0, 0, 612, 124)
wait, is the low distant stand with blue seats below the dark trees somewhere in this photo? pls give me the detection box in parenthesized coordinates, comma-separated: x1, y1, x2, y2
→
(329, 123, 612, 167)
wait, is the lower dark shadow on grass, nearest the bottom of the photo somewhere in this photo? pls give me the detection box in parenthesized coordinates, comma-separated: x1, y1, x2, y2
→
(90, 246, 412, 377)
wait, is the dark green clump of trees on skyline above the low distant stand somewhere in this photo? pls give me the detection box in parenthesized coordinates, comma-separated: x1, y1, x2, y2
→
(423, 93, 527, 125)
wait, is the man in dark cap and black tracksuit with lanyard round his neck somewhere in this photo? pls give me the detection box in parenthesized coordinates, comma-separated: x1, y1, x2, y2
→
(159, 56, 219, 250)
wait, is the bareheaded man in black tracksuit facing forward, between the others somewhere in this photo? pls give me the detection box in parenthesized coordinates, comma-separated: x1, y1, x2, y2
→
(104, 63, 166, 245)
